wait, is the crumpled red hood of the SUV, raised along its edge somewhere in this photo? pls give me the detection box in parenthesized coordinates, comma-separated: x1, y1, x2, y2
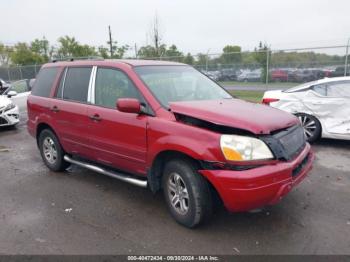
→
(170, 99, 298, 134)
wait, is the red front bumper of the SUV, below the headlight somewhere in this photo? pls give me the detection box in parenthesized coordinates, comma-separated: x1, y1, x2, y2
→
(199, 144, 315, 212)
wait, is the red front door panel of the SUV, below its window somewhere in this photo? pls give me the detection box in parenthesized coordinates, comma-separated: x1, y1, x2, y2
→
(88, 105, 148, 175)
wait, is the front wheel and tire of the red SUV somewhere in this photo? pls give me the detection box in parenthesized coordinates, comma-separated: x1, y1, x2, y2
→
(162, 159, 213, 228)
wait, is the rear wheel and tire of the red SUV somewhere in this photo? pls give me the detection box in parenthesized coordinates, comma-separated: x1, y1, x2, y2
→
(38, 129, 70, 172)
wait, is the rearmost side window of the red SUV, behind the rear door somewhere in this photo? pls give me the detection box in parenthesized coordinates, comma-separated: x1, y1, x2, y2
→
(32, 67, 58, 97)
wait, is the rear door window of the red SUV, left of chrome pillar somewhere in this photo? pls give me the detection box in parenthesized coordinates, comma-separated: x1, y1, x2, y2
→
(63, 67, 92, 103)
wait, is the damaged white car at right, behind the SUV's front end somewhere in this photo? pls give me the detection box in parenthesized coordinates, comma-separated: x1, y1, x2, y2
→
(262, 77, 350, 142)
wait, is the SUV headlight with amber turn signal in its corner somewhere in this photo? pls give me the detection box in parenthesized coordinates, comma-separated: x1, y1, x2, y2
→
(220, 135, 273, 161)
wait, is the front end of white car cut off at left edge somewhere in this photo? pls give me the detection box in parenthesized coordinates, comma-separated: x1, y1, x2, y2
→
(0, 95, 19, 127)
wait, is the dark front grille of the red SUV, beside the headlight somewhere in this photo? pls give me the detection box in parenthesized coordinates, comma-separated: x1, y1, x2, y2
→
(274, 125, 306, 158)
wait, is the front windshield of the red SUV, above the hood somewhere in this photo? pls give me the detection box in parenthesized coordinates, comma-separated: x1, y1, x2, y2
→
(135, 66, 232, 107)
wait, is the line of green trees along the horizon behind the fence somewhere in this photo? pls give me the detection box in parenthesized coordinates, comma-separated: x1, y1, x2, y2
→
(0, 35, 344, 68)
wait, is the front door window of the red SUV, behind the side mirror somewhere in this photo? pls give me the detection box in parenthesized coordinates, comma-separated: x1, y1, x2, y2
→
(95, 68, 141, 108)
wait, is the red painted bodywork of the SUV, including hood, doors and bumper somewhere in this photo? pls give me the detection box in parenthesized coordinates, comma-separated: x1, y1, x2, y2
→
(28, 60, 314, 211)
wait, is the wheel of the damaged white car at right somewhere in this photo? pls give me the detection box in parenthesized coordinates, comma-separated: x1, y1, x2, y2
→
(296, 113, 322, 143)
